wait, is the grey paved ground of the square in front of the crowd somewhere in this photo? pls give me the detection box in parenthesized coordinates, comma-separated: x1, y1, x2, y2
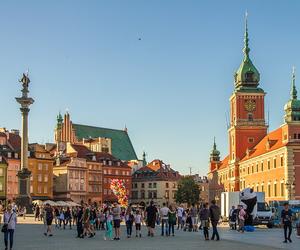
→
(0, 220, 300, 250)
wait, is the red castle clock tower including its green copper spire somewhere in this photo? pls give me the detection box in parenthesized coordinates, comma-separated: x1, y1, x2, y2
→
(228, 14, 267, 191)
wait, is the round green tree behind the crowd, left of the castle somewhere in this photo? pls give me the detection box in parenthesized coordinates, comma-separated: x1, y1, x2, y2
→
(175, 176, 200, 205)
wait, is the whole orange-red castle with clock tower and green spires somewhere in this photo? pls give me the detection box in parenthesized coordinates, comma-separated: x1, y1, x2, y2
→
(208, 19, 300, 201)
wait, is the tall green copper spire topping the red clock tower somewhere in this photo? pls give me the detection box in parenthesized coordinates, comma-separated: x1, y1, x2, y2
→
(234, 12, 263, 92)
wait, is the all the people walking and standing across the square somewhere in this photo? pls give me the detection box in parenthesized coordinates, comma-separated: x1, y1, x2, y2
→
(0, 200, 292, 250)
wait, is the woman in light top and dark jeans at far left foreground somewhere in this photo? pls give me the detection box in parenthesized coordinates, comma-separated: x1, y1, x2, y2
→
(2, 204, 17, 250)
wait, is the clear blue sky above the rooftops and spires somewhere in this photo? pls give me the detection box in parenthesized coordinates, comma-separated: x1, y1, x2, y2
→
(0, 0, 300, 174)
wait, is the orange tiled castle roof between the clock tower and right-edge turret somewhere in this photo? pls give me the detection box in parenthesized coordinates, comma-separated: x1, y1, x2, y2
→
(241, 127, 287, 161)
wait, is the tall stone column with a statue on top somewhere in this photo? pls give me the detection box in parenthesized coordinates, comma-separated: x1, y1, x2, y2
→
(16, 73, 34, 212)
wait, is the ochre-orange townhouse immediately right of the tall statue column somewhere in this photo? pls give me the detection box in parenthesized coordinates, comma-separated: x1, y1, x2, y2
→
(28, 143, 53, 200)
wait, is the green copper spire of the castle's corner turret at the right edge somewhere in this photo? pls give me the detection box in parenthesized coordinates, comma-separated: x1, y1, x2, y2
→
(284, 67, 300, 123)
